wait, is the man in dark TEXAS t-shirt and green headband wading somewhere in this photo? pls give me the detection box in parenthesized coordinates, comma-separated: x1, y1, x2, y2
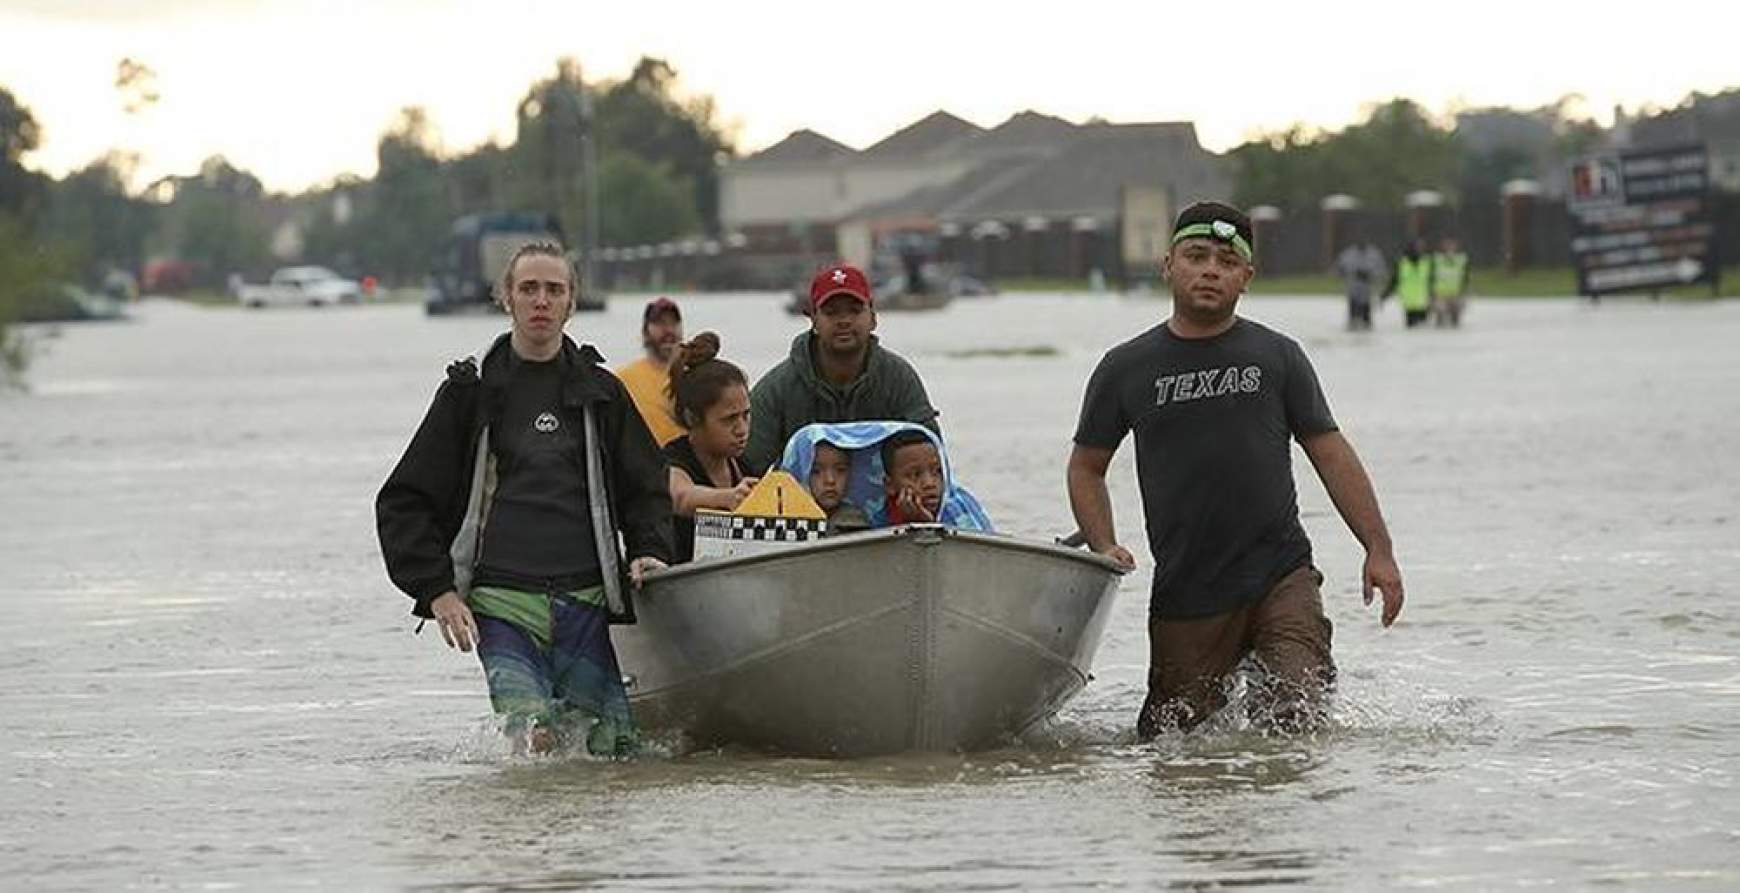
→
(1068, 202, 1402, 738)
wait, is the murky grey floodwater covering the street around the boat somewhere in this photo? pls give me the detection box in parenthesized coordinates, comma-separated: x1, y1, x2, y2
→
(0, 294, 1740, 890)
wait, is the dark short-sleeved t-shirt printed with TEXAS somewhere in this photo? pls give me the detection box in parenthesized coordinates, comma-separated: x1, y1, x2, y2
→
(1075, 319, 1336, 618)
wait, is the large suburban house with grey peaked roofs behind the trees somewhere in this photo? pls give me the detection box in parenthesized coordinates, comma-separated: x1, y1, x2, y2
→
(720, 111, 1230, 285)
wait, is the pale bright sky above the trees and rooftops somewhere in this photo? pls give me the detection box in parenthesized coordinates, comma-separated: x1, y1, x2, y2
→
(0, 0, 1740, 190)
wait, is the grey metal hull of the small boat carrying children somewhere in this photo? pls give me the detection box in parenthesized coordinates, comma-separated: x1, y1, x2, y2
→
(612, 524, 1119, 755)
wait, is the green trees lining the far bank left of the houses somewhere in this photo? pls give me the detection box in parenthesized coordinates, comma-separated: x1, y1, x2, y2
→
(0, 57, 734, 304)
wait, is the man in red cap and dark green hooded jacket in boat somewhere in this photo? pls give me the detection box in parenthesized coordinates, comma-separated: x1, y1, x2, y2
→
(743, 263, 941, 472)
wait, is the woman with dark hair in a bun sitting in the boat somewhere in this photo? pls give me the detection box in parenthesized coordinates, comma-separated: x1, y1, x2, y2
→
(665, 332, 755, 562)
